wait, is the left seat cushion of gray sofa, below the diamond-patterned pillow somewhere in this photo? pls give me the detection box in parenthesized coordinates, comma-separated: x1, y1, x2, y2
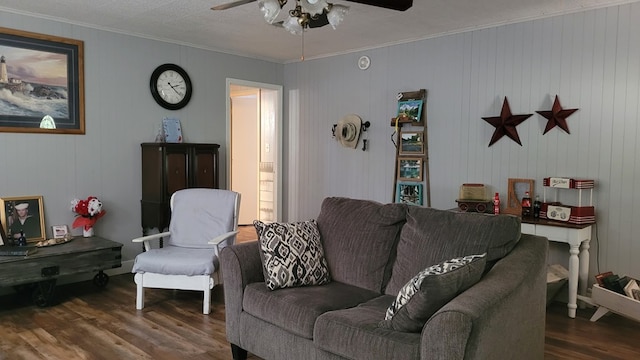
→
(242, 281, 384, 339)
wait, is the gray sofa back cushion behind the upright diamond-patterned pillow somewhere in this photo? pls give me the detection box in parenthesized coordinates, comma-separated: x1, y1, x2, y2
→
(317, 197, 408, 295)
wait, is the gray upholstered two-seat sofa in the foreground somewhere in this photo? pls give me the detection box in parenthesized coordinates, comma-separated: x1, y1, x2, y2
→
(220, 198, 547, 360)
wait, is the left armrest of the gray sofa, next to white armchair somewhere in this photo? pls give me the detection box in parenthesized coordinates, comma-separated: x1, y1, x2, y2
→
(220, 241, 264, 345)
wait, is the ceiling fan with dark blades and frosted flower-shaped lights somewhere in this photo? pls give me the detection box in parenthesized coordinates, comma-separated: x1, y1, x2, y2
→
(211, 0, 413, 34)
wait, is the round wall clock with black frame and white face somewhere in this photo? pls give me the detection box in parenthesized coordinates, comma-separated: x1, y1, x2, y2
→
(149, 64, 192, 110)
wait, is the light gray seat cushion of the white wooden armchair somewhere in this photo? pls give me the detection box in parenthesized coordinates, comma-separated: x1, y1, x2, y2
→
(132, 246, 218, 276)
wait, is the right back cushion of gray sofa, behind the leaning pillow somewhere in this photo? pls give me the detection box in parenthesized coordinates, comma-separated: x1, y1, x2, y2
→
(385, 206, 520, 296)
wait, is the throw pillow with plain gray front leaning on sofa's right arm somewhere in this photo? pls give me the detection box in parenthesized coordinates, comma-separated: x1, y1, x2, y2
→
(379, 253, 487, 332)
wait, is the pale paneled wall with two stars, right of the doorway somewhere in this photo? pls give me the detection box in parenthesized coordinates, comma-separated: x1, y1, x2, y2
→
(284, 3, 640, 278)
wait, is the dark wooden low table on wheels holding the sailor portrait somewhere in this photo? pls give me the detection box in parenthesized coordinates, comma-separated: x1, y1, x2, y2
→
(0, 236, 122, 306)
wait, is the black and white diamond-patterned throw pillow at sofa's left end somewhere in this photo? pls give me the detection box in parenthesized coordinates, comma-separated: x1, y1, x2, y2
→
(253, 220, 331, 290)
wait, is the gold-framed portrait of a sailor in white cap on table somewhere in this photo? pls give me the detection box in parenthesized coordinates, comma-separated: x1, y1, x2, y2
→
(0, 195, 47, 245)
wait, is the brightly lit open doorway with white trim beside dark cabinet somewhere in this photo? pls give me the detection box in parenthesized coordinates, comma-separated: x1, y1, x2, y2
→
(227, 79, 282, 225)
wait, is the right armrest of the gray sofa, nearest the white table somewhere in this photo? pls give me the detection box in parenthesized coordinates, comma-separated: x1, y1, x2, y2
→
(420, 234, 548, 359)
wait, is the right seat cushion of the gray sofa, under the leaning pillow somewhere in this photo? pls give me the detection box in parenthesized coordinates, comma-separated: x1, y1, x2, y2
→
(313, 295, 421, 360)
